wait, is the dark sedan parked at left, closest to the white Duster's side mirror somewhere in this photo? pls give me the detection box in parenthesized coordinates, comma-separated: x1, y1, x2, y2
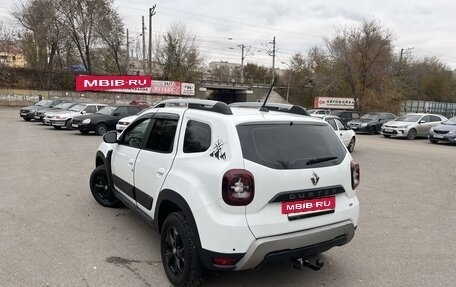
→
(71, 106, 140, 135)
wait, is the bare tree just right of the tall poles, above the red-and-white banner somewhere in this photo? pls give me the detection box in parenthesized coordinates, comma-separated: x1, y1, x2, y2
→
(155, 23, 203, 81)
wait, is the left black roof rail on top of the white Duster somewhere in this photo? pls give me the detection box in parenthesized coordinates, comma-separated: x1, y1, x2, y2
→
(154, 99, 233, 115)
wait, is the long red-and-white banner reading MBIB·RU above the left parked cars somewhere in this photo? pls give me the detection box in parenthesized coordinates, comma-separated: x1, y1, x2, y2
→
(76, 75, 195, 96)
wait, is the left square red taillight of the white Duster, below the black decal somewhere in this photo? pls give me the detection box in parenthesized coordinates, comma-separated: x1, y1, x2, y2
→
(222, 169, 255, 206)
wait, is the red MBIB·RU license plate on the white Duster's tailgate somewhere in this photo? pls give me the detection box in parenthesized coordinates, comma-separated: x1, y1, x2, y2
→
(282, 196, 336, 214)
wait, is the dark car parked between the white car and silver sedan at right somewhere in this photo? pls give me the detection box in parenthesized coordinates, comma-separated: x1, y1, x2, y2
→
(347, 112, 397, 135)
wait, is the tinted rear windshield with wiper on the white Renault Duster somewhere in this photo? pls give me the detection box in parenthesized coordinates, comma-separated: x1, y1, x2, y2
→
(237, 122, 347, 169)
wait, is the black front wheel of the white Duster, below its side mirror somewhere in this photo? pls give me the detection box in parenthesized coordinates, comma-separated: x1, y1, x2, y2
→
(90, 165, 122, 207)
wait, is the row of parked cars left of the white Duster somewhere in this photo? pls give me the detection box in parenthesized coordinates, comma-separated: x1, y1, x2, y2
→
(20, 100, 145, 135)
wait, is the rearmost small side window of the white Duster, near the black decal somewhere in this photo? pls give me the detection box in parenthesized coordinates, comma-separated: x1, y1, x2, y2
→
(184, 120, 211, 153)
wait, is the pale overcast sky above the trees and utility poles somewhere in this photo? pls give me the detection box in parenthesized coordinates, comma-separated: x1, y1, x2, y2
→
(0, 0, 456, 69)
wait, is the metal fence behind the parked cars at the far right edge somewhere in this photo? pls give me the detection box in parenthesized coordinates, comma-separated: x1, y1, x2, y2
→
(401, 100, 456, 118)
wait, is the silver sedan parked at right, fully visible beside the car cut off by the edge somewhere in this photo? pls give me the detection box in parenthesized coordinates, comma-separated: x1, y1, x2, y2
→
(381, 113, 447, 140)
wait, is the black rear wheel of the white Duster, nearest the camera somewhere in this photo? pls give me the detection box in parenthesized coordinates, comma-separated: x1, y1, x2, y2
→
(160, 212, 204, 287)
